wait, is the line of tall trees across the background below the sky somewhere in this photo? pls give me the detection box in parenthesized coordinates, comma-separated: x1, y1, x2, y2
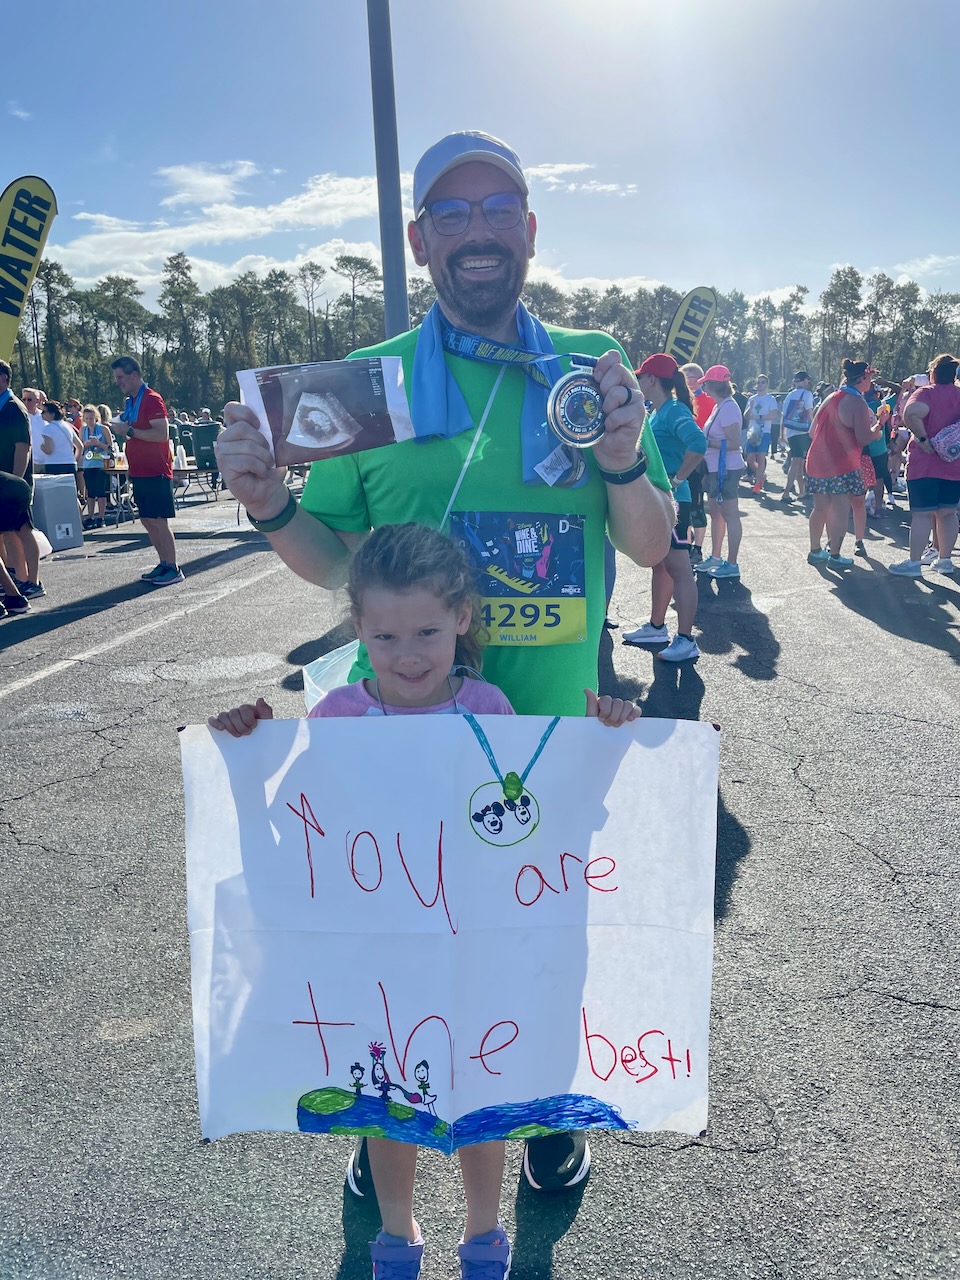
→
(13, 253, 960, 410)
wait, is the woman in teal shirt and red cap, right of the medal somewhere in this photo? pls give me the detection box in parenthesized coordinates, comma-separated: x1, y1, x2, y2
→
(623, 353, 707, 662)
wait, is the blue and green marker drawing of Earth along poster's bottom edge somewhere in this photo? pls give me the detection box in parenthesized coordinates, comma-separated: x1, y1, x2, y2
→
(297, 1088, 634, 1156)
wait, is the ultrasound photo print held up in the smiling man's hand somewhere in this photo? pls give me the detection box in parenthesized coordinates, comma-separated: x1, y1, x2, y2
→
(237, 356, 413, 466)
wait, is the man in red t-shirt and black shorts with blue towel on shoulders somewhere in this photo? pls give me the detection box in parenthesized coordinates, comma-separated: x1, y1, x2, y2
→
(110, 356, 183, 586)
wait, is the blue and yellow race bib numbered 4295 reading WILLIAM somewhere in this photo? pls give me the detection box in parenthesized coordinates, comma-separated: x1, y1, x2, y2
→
(451, 511, 586, 646)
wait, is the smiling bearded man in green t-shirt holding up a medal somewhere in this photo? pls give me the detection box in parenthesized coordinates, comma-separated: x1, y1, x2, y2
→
(216, 133, 673, 1228)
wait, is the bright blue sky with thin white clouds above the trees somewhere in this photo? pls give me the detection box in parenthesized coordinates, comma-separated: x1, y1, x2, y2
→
(13, 0, 960, 312)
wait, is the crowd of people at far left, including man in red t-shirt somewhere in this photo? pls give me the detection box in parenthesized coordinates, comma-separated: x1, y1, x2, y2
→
(0, 366, 227, 618)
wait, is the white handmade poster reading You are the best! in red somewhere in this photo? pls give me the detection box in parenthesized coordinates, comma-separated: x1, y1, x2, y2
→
(180, 716, 719, 1152)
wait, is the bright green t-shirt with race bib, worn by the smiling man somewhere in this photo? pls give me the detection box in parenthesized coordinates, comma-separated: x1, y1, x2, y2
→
(301, 325, 669, 716)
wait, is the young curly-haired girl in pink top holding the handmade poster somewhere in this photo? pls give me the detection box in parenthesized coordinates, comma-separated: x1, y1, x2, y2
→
(209, 524, 640, 1280)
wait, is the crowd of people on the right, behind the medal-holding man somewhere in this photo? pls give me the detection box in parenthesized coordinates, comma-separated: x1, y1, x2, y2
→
(623, 355, 960, 662)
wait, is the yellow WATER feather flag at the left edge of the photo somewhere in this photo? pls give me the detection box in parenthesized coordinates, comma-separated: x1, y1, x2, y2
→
(0, 177, 56, 360)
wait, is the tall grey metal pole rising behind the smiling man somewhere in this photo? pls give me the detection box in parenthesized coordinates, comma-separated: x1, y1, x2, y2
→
(366, 0, 410, 338)
